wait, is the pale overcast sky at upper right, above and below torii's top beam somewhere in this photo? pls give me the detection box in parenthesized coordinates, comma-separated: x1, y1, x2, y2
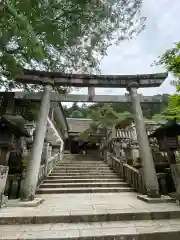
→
(68, 0, 180, 100)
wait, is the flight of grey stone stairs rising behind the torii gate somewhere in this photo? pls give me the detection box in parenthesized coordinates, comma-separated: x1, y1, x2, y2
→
(37, 158, 134, 194)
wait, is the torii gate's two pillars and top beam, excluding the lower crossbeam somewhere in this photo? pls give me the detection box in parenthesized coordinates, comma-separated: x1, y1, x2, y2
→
(15, 70, 167, 201)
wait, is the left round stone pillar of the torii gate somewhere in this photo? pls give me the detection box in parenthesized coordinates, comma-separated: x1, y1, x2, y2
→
(21, 83, 53, 201)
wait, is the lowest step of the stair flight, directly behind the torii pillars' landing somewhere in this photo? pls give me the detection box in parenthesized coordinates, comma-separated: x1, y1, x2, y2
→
(36, 187, 135, 194)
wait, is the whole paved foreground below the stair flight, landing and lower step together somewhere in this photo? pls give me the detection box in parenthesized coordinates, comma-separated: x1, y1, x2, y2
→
(0, 193, 180, 240)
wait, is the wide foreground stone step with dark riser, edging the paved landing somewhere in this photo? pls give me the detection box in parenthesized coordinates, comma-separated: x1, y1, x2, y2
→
(0, 208, 180, 226)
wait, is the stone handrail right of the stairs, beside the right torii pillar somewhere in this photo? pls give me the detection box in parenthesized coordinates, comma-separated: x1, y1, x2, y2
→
(110, 156, 146, 194)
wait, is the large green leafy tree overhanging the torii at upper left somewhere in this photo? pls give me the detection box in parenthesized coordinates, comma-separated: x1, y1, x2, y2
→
(0, 0, 145, 90)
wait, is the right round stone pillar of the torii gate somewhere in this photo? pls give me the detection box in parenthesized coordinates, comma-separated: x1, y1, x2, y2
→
(127, 82, 159, 197)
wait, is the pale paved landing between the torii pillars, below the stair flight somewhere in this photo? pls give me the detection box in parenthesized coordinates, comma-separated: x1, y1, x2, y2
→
(0, 193, 180, 218)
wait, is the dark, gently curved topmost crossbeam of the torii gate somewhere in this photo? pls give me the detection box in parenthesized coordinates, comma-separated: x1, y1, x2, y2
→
(15, 70, 168, 88)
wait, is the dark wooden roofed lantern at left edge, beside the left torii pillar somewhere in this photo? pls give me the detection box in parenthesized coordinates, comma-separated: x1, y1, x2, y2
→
(0, 115, 30, 201)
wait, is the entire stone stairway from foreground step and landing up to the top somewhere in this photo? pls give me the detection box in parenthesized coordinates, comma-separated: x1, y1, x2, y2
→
(0, 156, 180, 240)
